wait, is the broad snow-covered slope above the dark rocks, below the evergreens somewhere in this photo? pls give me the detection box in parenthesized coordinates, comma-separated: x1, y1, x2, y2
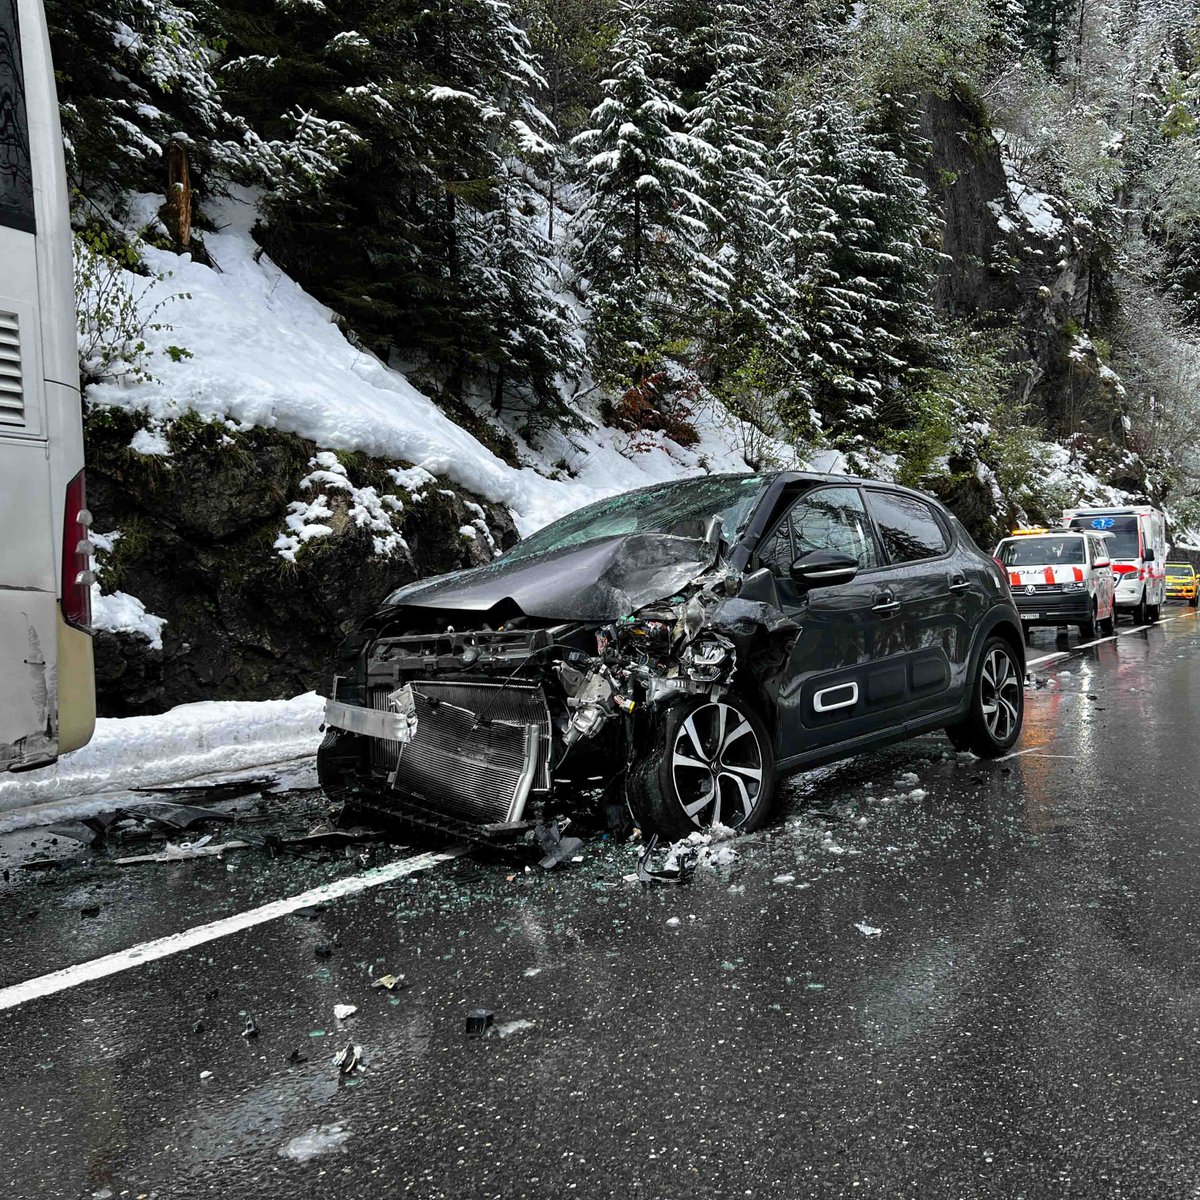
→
(89, 189, 777, 534)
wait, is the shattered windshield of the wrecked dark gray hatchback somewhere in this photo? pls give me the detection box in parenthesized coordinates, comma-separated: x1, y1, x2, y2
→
(505, 475, 764, 560)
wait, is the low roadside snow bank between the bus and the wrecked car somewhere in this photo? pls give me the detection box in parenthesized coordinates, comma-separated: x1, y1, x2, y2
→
(0, 692, 325, 812)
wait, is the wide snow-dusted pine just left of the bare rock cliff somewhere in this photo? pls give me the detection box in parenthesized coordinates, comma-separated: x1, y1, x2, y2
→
(773, 98, 940, 440)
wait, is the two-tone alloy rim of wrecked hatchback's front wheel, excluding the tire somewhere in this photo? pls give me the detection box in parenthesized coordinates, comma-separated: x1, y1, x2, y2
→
(671, 701, 763, 828)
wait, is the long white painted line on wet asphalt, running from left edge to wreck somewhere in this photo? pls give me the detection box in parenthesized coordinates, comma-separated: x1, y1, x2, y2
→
(0, 846, 469, 1012)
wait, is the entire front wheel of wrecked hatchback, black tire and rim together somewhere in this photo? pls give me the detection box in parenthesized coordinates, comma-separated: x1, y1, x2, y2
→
(629, 695, 776, 840)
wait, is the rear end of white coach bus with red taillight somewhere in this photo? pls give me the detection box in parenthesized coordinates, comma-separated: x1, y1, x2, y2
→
(0, 0, 96, 772)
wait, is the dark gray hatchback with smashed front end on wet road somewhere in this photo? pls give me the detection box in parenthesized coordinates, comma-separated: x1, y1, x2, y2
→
(318, 472, 1025, 838)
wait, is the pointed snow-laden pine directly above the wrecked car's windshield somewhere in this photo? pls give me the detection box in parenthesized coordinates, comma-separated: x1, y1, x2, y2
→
(572, 0, 708, 384)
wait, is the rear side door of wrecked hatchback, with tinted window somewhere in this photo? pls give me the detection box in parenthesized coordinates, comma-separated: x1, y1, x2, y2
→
(866, 487, 964, 719)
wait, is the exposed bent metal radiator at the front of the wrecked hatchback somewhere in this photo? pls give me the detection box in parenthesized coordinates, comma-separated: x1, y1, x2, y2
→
(371, 680, 550, 823)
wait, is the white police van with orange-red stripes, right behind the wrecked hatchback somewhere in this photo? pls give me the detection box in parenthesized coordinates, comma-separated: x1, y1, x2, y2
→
(992, 529, 1116, 640)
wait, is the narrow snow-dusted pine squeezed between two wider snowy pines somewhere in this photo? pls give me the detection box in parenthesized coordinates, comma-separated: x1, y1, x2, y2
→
(686, 0, 787, 382)
